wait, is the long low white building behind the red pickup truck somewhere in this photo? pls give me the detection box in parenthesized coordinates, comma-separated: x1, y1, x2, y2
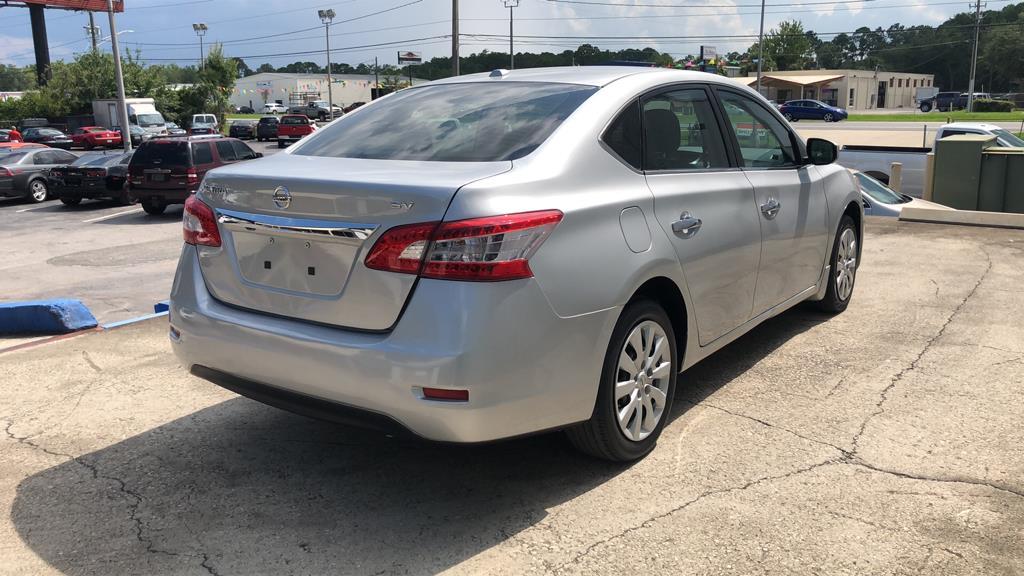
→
(230, 72, 427, 112)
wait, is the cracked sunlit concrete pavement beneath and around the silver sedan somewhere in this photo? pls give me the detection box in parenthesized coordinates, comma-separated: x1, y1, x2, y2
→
(0, 220, 1024, 576)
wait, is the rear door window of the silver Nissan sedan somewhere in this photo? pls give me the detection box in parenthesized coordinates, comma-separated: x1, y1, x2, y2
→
(643, 88, 729, 170)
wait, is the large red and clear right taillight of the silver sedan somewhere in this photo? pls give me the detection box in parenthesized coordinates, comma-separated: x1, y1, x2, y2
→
(367, 210, 562, 282)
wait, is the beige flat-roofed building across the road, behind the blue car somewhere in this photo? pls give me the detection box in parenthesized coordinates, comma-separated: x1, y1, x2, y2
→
(737, 70, 935, 110)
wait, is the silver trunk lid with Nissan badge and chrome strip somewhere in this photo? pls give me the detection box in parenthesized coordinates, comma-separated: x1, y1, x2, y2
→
(193, 154, 511, 330)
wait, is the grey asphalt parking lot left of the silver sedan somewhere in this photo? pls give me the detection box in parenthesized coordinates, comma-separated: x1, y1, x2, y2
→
(0, 141, 280, 327)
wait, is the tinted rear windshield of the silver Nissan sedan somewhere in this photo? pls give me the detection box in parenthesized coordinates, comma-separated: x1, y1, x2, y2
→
(295, 82, 597, 162)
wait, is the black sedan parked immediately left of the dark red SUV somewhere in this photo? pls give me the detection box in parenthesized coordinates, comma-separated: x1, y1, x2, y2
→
(48, 152, 133, 206)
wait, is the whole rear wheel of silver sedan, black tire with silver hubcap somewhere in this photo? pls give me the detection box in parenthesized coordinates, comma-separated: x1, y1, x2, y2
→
(565, 300, 678, 462)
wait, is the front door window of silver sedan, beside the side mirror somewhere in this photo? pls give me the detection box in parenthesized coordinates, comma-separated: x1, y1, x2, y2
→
(719, 91, 797, 168)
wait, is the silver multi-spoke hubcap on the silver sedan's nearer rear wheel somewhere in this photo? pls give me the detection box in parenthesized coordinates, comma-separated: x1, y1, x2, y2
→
(615, 320, 673, 442)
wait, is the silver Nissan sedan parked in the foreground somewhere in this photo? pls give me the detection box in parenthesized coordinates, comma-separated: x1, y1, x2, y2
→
(170, 67, 863, 460)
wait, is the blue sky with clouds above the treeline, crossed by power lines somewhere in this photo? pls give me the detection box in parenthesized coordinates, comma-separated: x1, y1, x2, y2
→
(0, 0, 1008, 69)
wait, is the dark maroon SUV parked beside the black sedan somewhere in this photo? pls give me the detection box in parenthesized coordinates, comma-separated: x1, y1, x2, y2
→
(128, 135, 263, 215)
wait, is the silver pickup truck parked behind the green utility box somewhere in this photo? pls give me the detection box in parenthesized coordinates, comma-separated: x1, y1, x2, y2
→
(837, 122, 1024, 198)
